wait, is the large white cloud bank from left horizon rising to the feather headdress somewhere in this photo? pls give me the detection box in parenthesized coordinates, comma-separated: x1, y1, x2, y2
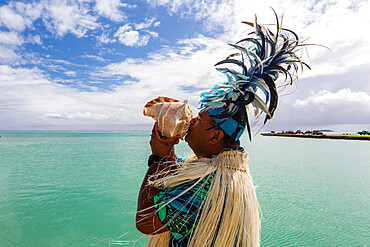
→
(0, 37, 223, 129)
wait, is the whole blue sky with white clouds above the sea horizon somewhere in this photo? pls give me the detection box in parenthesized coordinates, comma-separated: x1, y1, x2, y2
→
(0, 0, 370, 131)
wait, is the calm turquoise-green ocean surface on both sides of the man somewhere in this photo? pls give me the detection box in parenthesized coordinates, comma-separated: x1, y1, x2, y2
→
(0, 131, 370, 247)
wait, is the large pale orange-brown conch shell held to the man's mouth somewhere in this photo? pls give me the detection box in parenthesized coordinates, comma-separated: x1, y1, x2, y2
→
(143, 96, 193, 139)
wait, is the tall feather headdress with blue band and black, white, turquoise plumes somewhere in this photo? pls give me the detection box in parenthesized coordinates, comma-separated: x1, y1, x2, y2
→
(199, 11, 310, 140)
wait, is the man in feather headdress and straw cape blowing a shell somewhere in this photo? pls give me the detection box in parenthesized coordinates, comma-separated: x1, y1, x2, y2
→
(136, 13, 308, 247)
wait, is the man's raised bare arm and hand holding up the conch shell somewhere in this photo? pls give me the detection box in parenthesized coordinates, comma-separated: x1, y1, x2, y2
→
(136, 123, 179, 234)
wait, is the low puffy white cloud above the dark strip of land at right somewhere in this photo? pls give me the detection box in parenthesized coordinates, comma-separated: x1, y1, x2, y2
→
(270, 88, 370, 128)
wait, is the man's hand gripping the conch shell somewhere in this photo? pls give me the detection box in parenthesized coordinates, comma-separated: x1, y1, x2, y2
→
(150, 122, 180, 159)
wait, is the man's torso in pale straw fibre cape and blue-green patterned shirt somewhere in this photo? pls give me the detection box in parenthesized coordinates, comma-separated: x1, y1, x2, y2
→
(145, 150, 260, 247)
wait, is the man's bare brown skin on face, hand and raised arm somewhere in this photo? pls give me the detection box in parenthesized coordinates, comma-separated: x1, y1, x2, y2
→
(136, 110, 224, 234)
